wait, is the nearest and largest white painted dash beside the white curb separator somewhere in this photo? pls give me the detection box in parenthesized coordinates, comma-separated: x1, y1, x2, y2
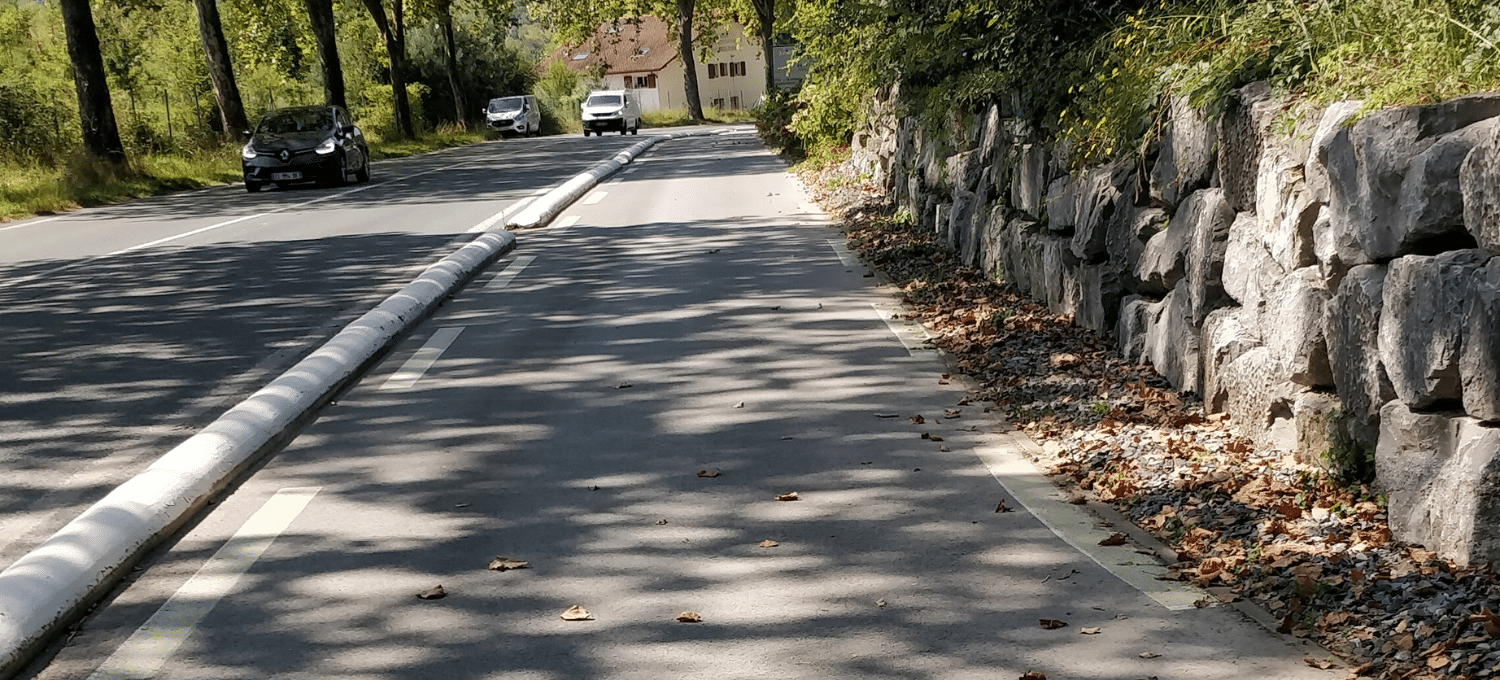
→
(89, 486, 321, 680)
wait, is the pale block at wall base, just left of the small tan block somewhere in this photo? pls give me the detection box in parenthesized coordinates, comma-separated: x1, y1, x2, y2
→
(1218, 347, 1307, 453)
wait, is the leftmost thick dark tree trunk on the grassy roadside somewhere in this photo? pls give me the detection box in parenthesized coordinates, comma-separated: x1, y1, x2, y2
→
(59, 0, 125, 165)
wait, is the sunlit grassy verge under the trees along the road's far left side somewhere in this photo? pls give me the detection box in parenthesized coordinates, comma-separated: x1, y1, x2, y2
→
(0, 131, 486, 221)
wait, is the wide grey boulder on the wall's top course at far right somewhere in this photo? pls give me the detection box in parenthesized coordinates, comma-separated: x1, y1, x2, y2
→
(1319, 95, 1500, 261)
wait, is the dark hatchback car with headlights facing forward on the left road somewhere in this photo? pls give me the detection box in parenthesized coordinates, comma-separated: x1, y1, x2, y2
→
(240, 107, 371, 192)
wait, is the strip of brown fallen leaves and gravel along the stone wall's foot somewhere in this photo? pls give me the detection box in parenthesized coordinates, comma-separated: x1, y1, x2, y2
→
(804, 167, 1500, 680)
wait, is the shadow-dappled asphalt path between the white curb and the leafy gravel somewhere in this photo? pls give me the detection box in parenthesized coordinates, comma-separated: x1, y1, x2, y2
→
(20, 135, 1334, 680)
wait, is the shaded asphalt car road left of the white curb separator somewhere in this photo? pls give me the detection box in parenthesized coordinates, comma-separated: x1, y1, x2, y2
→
(0, 131, 638, 567)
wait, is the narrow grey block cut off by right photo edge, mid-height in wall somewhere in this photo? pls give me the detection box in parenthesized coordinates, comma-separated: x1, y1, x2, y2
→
(1458, 258, 1500, 422)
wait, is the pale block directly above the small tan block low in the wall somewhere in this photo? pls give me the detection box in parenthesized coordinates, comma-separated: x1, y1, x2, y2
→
(1260, 267, 1334, 387)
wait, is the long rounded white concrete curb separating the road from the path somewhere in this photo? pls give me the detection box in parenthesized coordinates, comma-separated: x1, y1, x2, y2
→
(0, 126, 711, 677)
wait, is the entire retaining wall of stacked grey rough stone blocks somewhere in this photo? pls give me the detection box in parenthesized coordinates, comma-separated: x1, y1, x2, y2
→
(854, 84, 1500, 563)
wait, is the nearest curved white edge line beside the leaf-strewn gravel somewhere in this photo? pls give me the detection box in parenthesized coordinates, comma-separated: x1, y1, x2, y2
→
(974, 432, 1208, 611)
